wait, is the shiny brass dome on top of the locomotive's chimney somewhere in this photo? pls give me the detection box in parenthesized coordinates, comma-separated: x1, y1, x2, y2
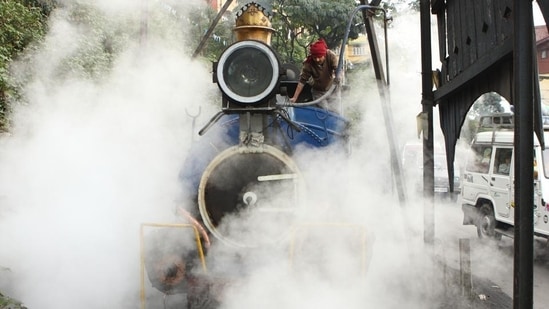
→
(233, 2, 274, 45)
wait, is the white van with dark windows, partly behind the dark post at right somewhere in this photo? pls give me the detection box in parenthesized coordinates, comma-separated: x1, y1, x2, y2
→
(461, 116, 549, 238)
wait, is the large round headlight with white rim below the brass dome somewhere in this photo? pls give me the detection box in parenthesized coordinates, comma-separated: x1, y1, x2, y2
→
(216, 41, 280, 104)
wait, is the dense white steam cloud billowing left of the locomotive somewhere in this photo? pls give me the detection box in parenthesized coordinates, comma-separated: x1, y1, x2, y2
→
(0, 1, 216, 308)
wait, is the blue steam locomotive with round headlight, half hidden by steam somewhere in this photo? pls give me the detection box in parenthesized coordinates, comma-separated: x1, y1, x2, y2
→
(141, 2, 356, 308)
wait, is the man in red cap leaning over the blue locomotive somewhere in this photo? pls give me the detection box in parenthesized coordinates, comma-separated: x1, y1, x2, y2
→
(290, 39, 338, 112)
